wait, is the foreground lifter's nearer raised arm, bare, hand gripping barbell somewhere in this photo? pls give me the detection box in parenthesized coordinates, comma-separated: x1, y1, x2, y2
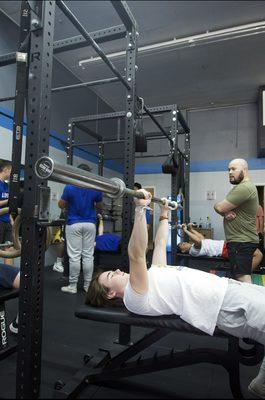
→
(128, 189, 151, 294)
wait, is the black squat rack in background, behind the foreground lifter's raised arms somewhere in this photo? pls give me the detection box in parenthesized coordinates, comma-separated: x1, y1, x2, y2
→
(67, 104, 190, 266)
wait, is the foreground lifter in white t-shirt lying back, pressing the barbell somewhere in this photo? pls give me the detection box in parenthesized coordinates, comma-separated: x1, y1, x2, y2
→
(86, 189, 265, 398)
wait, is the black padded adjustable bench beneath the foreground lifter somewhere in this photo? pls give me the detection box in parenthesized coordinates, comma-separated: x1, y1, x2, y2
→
(54, 305, 264, 399)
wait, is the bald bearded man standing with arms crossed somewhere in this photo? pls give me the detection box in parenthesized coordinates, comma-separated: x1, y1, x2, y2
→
(214, 158, 259, 283)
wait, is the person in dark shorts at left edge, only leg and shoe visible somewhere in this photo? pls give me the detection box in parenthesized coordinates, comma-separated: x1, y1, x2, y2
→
(0, 263, 20, 334)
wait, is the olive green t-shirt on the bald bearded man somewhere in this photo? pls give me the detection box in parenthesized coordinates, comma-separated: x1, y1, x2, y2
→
(224, 181, 259, 243)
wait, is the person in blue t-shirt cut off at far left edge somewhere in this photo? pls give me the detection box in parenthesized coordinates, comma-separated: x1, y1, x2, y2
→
(0, 160, 12, 264)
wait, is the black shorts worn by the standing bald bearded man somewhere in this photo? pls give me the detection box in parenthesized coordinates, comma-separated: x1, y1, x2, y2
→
(227, 242, 259, 277)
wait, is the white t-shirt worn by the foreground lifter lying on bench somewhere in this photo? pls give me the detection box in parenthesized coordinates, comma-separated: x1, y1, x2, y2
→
(123, 265, 228, 335)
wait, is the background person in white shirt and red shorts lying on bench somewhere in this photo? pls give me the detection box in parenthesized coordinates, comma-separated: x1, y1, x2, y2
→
(177, 224, 263, 271)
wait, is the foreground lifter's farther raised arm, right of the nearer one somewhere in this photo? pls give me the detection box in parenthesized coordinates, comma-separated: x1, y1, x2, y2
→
(152, 199, 169, 266)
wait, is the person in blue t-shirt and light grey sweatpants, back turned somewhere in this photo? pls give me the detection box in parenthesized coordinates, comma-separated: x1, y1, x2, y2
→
(58, 164, 102, 294)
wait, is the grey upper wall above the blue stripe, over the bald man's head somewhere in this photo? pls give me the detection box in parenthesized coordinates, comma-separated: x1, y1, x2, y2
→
(187, 103, 257, 162)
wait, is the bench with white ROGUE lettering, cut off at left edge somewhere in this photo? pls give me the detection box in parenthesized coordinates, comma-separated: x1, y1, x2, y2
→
(0, 288, 19, 360)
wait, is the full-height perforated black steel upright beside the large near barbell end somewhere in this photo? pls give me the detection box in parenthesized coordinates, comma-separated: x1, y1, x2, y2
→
(16, 1, 55, 399)
